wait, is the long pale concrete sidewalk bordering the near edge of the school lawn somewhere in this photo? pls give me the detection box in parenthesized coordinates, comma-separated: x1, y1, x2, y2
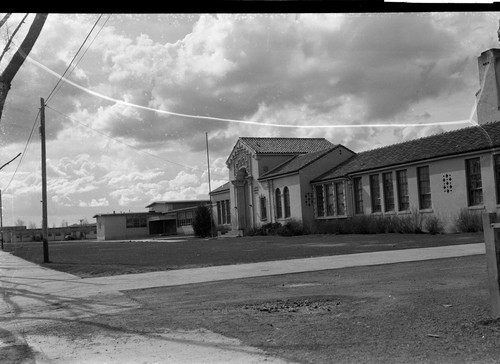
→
(0, 243, 485, 298)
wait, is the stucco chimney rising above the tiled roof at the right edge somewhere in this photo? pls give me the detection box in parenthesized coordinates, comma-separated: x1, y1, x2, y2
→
(476, 48, 500, 124)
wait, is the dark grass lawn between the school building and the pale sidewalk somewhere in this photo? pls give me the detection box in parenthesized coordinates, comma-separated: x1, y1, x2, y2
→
(0, 233, 484, 277)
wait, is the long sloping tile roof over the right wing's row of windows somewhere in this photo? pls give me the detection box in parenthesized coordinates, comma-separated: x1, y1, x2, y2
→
(312, 122, 500, 182)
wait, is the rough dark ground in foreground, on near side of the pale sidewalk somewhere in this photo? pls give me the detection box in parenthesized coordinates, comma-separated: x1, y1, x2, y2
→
(119, 256, 500, 364)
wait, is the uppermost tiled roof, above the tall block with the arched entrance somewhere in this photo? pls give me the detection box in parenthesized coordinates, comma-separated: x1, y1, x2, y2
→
(239, 137, 334, 154)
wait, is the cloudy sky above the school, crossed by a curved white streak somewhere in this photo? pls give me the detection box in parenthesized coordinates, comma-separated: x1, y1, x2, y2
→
(0, 12, 500, 227)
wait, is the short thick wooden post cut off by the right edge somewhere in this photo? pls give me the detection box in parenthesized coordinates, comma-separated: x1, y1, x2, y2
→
(483, 212, 500, 318)
